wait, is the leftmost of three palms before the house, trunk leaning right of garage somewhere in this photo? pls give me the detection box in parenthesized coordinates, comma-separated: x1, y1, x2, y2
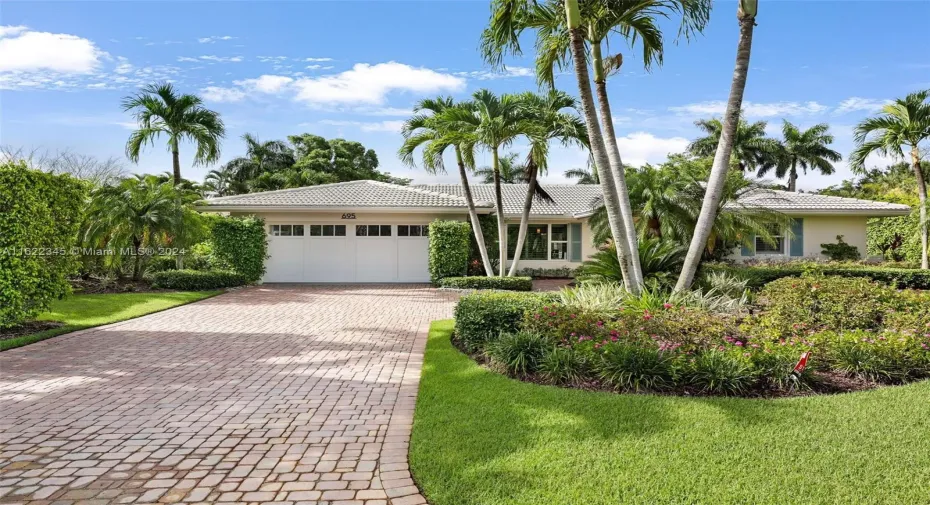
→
(398, 97, 492, 277)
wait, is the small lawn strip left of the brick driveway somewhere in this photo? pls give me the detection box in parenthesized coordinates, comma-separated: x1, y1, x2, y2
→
(0, 291, 221, 351)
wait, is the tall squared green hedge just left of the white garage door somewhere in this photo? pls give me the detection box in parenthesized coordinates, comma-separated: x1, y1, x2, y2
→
(213, 217, 268, 282)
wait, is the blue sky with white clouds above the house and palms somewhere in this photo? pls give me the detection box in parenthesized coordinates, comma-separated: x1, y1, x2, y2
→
(0, 0, 930, 189)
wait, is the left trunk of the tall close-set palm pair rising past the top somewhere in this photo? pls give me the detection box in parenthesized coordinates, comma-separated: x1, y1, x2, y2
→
(565, 0, 640, 295)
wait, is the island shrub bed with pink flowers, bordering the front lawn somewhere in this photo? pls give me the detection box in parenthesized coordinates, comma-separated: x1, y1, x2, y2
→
(456, 276, 930, 396)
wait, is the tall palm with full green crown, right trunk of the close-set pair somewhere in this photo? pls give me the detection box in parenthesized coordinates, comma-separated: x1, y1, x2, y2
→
(482, 0, 710, 292)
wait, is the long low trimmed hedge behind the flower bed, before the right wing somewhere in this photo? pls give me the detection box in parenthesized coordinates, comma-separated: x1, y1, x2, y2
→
(704, 263, 930, 290)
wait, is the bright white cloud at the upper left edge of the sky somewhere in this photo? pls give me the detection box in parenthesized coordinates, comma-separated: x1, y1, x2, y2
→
(0, 26, 109, 74)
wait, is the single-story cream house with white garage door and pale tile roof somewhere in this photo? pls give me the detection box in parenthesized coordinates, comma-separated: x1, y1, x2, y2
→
(199, 181, 910, 282)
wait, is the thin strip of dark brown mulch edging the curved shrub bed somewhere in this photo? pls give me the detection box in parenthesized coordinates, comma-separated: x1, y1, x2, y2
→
(452, 337, 882, 398)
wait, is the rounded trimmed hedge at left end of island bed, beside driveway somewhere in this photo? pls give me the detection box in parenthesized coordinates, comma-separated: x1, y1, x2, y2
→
(455, 291, 553, 350)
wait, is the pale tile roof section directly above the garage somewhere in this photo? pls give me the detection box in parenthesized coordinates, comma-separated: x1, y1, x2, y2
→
(204, 181, 492, 209)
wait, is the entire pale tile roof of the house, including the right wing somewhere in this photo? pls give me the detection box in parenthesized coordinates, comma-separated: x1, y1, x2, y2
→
(204, 181, 910, 217)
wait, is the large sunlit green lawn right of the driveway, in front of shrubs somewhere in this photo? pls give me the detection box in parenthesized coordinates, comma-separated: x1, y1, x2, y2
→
(410, 321, 930, 505)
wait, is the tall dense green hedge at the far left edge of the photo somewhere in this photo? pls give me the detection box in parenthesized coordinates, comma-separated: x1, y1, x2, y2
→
(0, 162, 86, 328)
